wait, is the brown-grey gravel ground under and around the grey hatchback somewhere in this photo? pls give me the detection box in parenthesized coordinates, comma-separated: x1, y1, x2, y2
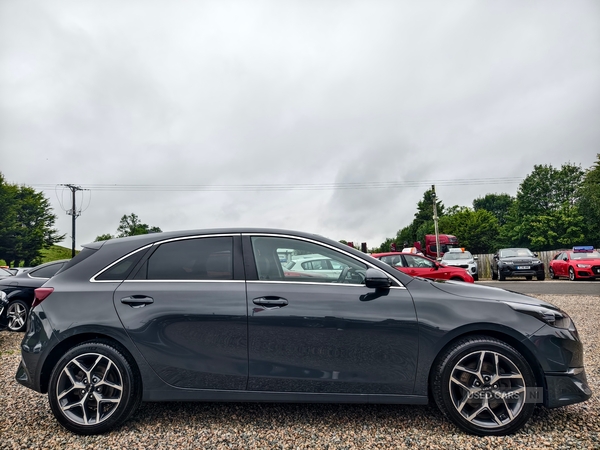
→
(0, 295, 600, 450)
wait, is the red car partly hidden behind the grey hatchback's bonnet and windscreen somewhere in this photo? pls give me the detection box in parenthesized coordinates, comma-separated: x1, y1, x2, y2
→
(371, 252, 475, 283)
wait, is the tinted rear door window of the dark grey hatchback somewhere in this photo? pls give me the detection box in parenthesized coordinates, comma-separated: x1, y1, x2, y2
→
(135, 237, 233, 280)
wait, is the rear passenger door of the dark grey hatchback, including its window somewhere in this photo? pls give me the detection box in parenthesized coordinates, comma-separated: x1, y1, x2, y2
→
(113, 235, 248, 390)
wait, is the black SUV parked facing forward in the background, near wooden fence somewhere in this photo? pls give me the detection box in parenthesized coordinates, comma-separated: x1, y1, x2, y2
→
(491, 248, 546, 281)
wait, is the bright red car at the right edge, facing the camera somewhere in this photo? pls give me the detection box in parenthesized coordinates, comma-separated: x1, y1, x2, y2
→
(548, 245, 600, 281)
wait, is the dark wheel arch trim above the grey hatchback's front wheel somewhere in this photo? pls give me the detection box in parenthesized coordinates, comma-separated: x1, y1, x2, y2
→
(427, 329, 546, 400)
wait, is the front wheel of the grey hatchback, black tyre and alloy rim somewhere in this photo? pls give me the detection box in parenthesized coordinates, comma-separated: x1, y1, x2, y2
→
(431, 336, 535, 436)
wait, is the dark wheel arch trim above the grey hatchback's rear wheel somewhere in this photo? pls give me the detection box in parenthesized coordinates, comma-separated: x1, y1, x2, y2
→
(40, 332, 143, 394)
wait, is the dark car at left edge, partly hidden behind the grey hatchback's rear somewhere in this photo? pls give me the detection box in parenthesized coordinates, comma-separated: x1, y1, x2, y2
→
(0, 259, 69, 331)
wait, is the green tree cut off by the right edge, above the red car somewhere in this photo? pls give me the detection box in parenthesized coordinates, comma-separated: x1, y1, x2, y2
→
(579, 153, 600, 247)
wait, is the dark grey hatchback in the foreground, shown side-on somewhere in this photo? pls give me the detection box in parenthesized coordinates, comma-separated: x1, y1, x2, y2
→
(16, 229, 591, 435)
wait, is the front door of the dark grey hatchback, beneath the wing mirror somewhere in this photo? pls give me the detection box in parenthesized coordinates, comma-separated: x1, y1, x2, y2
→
(244, 235, 418, 394)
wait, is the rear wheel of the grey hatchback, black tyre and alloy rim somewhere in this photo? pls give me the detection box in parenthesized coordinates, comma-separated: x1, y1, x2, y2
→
(48, 340, 142, 434)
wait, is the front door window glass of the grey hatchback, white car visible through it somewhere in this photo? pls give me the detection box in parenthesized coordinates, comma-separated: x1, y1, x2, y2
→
(252, 237, 367, 284)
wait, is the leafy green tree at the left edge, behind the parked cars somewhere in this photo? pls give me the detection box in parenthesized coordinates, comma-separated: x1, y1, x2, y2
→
(0, 174, 64, 266)
